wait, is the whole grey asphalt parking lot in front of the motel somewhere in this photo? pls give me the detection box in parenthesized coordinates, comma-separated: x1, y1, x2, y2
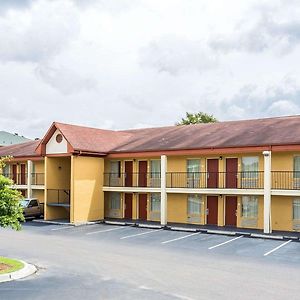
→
(0, 222, 300, 299)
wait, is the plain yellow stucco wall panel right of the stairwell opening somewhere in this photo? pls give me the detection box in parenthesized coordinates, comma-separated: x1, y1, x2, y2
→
(71, 156, 104, 223)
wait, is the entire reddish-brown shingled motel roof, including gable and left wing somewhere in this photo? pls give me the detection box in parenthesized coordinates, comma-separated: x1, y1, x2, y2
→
(0, 116, 300, 157)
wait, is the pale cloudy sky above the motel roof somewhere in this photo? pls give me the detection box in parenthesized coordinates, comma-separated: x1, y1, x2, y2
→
(0, 0, 300, 138)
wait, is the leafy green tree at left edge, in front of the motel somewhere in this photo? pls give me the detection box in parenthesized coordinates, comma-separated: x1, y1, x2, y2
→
(0, 157, 24, 230)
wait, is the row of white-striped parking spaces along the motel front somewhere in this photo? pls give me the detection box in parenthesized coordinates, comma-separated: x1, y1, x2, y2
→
(19, 222, 300, 263)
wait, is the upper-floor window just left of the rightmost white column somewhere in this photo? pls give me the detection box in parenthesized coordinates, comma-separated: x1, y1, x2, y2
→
(242, 156, 258, 188)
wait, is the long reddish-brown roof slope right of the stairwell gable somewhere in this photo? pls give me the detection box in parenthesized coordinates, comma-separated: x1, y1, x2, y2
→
(111, 116, 300, 152)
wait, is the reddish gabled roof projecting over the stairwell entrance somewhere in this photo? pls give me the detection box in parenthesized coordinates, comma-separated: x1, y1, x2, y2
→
(37, 122, 132, 155)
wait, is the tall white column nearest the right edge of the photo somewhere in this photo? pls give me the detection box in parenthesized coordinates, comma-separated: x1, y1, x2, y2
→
(263, 151, 272, 233)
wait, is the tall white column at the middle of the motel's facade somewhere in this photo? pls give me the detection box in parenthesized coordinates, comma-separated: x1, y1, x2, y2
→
(160, 155, 167, 226)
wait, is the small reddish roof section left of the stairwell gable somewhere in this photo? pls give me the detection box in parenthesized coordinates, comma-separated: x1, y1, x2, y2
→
(0, 141, 40, 158)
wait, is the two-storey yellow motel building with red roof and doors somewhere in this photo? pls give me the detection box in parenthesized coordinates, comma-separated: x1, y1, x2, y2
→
(0, 116, 300, 233)
